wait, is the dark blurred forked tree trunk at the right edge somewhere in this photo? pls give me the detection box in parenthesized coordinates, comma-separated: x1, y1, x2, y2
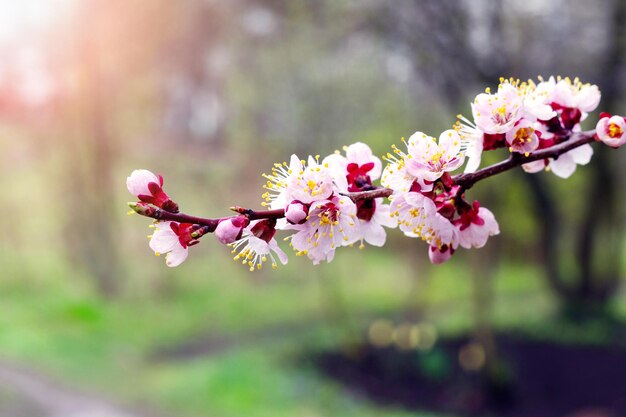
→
(526, 0, 626, 320)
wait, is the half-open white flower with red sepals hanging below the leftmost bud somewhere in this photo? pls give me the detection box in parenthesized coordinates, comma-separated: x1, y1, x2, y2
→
(150, 222, 201, 267)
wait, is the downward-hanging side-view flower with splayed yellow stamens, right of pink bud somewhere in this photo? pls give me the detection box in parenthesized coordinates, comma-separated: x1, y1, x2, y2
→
(230, 219, 287, 271)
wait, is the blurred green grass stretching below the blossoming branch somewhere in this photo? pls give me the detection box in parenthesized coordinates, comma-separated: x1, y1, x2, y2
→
(0, 237, 564, 417)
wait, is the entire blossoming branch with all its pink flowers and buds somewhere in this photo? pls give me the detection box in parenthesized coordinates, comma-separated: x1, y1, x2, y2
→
(127, 77, 626, 271)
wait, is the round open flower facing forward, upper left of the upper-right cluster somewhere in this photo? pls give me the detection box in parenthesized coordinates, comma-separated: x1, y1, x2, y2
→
(472, 82, 524, 134)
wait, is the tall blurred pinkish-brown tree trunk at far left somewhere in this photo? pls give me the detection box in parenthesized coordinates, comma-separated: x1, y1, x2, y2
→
(65, 0, 120, 296)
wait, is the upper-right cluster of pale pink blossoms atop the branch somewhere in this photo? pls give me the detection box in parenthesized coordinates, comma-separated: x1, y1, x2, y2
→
(455, 77, 600, 178)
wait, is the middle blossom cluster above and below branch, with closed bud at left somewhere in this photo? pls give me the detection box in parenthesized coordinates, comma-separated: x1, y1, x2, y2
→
(274, 142, 394, 264)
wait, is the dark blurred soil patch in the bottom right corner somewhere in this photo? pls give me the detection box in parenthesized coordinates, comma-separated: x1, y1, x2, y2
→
(315, 337, 626, 417)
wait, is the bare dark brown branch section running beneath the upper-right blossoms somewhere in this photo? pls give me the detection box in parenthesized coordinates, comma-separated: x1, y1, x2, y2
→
(452, 130, 595, 190)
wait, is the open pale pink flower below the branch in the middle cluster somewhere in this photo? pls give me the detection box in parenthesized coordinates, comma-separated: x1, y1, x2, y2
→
(286, 196, 357, 265)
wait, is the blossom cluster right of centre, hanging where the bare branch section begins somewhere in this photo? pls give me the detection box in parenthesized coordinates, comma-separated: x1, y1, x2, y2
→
(382, 130, 499, 263)
